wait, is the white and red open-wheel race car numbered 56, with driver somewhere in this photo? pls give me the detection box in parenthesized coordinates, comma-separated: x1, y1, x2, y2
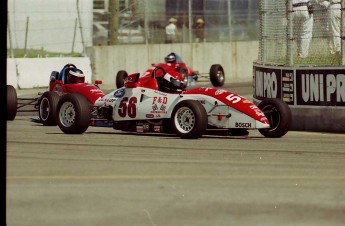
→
(56, 67, 291, 139)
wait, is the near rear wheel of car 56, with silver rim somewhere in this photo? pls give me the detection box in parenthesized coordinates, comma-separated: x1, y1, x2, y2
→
(57, 93, 91, 134)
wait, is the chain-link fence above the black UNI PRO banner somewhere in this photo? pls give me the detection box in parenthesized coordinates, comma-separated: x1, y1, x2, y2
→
(258, 0, 345, 66)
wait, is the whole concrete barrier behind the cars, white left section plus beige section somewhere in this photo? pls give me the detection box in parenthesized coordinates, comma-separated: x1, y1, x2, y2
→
(7, 41, 258, 88)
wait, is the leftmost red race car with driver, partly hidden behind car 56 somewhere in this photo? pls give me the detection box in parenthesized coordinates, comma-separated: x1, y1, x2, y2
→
(7, 64, 105, 126)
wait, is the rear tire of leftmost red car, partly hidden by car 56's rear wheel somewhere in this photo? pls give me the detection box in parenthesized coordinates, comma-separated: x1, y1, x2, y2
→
(38, 91, 60, 126)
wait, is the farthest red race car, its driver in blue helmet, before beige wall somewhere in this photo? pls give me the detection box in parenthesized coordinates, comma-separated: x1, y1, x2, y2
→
(115, 53, 225, 88)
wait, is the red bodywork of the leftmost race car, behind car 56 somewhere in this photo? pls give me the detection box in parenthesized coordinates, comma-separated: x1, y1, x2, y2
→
(49, 80, 105, 105)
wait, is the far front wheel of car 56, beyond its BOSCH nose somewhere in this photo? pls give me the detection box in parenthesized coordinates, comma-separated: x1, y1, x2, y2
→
(258, 98, 292, 138)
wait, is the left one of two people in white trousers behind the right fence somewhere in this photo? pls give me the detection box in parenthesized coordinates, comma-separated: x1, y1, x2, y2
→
(292, 0, 313, 58)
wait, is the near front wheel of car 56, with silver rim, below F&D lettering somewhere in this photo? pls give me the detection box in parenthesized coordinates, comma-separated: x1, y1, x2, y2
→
(171, 100, 208, 139)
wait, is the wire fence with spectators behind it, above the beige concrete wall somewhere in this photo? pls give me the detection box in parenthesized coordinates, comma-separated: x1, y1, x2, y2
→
(94, 0, 259, 45)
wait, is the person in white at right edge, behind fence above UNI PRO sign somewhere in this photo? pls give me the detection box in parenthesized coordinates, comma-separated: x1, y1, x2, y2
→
(318, 0, 341, 54)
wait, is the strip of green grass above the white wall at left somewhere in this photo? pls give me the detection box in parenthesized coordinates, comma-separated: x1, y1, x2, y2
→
(7, 49, 82, 58)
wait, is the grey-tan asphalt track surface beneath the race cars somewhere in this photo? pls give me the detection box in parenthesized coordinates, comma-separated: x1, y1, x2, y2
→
(6, 85, 345, 226)
